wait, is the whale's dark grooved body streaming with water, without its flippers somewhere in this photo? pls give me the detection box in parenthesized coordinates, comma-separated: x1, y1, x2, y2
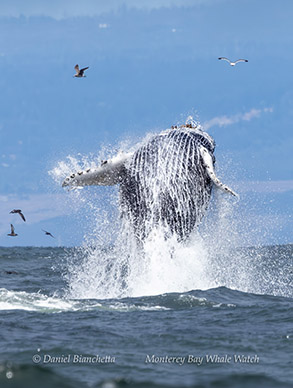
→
(120, 129, 214, 240)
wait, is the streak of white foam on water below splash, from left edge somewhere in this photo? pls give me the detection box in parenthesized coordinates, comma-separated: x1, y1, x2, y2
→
(0, 288, 238, 314)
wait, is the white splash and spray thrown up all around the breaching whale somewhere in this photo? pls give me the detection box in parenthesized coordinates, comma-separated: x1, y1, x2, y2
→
(51, 127, 284, 299)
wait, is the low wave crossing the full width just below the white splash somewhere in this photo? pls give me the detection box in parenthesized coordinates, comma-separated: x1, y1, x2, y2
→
(0, 287, 290, 313)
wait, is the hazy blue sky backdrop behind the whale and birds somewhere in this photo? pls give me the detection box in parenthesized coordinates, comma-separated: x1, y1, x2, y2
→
(0, 0, 293, 246)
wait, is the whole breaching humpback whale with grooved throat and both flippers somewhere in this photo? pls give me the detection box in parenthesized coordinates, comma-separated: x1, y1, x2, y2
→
(62, 124, 237, 240)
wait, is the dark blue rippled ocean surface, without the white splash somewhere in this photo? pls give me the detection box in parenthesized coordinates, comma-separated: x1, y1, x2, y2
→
(0, 245, 293, 388)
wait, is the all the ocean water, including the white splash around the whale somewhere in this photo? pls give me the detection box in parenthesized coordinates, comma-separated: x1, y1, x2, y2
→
(0, 128, 293, 388)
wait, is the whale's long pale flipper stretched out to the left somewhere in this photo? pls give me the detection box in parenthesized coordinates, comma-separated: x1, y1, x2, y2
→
(62, 153, 132, 187)
